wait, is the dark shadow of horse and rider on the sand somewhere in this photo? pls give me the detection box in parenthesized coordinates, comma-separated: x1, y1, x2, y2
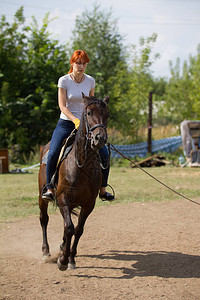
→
(74, 251, 200, 279)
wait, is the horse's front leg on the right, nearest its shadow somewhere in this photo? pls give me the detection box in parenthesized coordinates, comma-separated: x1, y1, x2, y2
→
(68, 208, 93, 269)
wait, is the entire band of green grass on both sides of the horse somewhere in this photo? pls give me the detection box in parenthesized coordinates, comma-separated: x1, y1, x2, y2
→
(0, 166, 200, 222)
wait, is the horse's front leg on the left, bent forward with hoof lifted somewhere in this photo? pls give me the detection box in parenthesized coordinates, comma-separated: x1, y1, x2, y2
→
(57, 196, 74, 271)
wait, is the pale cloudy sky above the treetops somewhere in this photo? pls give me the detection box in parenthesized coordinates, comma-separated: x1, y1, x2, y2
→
(0, 0, 200, 78)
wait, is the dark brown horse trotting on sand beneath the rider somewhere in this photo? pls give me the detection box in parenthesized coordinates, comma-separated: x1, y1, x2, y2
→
(39, 95, 109, 271)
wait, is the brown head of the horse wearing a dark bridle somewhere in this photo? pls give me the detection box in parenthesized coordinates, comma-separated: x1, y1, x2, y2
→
(83, 94, 109, 150)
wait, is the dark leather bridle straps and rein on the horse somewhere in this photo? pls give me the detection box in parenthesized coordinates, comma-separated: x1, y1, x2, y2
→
(75, 100, 110, 168)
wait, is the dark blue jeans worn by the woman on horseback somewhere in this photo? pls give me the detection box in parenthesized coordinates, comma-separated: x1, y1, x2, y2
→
(46, 119, 109, 188)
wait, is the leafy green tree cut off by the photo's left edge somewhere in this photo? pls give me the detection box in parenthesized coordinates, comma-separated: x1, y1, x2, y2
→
(0, 8, 28, 147)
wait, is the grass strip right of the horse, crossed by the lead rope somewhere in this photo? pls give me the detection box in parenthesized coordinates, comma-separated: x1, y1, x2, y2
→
(110, 166, 200, 202)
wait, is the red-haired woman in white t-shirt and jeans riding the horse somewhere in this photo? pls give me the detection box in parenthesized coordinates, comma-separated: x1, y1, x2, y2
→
(42, 50, 114, 201)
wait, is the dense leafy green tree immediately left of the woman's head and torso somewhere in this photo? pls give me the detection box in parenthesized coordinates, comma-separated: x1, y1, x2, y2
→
(24, 14, 69, 151)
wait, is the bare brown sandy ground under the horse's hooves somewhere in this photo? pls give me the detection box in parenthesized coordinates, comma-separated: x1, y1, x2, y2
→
(0, 199, 200, 300)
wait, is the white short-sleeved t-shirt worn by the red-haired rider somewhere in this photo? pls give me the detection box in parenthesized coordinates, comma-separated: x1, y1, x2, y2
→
(58, 74, 95, 120)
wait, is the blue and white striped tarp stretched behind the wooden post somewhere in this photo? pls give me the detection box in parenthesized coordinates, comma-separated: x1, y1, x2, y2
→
(111, 135, 182, 157)
